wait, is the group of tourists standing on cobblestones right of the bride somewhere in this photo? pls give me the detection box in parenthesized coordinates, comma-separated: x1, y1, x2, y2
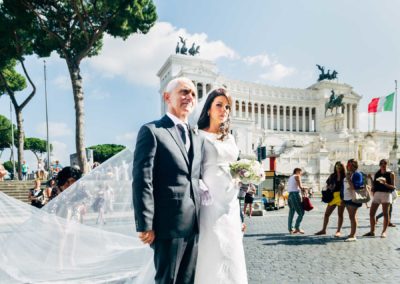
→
(296, 159, 397, 242)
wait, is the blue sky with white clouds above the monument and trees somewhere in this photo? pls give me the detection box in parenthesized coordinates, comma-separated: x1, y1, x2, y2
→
(0, 0, 400, 169)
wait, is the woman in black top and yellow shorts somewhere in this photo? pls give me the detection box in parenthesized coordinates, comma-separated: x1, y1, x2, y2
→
(315, 161, 345, 238)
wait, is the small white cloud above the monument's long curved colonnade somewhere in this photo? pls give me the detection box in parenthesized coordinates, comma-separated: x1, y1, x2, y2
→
(243, 53, 296, 81)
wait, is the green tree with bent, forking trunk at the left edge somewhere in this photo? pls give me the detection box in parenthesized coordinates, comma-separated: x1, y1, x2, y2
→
(0, 0, 37, 178)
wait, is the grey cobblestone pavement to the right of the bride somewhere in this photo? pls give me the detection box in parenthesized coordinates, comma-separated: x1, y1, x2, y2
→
(244, 199, 400, 284)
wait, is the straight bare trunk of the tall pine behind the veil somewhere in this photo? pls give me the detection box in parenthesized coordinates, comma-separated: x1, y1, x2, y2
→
(67, 61, 89, 173)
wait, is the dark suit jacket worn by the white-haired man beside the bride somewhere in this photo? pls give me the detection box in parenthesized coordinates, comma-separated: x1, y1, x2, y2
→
(132, 115, 203, 239)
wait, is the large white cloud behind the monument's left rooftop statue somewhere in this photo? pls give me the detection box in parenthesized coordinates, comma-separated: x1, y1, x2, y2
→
(88, 22, 239, 86)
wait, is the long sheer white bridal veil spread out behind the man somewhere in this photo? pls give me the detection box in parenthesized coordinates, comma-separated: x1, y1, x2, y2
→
(0, 150, 155, 283)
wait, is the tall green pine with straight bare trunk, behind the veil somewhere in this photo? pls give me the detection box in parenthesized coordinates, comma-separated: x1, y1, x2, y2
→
(14, 0, 157, 172)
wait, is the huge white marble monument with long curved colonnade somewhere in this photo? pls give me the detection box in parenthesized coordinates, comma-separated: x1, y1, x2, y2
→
(157, 55, 398, 189)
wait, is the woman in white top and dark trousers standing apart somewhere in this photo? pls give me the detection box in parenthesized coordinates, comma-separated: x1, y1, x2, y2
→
(288, 168, 306, 234)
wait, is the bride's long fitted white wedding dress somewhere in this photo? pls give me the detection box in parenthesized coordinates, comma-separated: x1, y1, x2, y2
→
(195, 131, 247, 284)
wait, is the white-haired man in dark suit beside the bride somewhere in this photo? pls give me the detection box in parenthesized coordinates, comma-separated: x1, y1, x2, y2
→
(132, 77, 202, 284)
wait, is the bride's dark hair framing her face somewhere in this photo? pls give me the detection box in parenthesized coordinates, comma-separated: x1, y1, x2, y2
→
(197, 88, 232, 140)
